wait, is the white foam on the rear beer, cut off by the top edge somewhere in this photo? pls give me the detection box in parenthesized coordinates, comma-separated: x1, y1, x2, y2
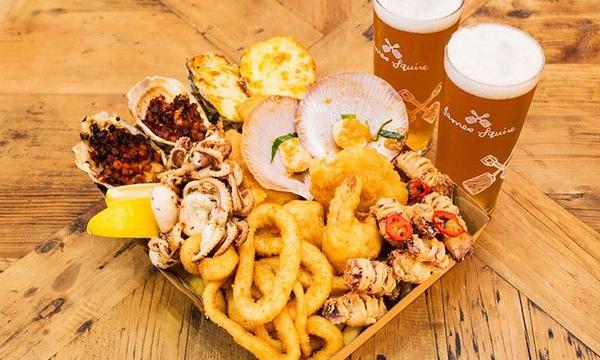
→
(373, 0, 463, 34)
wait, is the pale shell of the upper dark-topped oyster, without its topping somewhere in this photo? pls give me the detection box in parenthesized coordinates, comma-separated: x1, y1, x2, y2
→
(127, 75, 210, 146)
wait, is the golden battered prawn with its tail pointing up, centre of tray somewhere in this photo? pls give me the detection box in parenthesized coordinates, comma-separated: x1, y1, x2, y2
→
(323, 176, 382, 273)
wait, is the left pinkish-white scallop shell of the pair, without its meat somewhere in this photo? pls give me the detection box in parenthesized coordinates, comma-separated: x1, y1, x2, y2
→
(242, 96, 312, 199)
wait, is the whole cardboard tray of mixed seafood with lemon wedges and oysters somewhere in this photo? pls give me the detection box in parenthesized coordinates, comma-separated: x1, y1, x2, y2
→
(73, 37, 489, 359)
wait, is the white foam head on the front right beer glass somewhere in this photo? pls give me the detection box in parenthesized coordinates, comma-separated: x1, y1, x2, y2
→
(444, 23, 544, 99)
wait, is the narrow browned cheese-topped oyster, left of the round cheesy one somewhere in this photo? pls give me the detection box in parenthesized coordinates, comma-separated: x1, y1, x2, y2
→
(187, 53, 248, 122)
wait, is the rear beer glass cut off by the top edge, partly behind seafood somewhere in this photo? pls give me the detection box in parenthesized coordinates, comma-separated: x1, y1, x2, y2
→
(373, 0, 463, 154)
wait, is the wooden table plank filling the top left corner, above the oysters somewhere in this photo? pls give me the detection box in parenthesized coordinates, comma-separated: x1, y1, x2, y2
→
(0, 0, 212, 94)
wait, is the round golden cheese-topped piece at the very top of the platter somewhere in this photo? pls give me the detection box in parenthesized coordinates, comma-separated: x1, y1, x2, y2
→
(240, 37, 315, 99)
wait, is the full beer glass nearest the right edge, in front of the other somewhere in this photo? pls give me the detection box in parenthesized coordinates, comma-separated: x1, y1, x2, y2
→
(435, 23, 544, 213)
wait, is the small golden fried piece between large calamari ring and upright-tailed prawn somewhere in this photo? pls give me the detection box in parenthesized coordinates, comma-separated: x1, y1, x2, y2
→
(283, 200, 325, 249)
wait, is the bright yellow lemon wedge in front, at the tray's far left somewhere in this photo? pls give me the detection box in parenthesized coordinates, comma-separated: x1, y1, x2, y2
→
(87, 196, 158, 238)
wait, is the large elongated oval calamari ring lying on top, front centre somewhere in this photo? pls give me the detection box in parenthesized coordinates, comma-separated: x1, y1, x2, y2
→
(233, 204, 301, 324)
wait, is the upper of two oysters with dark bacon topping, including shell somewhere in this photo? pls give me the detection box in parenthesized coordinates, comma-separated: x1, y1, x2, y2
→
(127, 76, 212, 146)
